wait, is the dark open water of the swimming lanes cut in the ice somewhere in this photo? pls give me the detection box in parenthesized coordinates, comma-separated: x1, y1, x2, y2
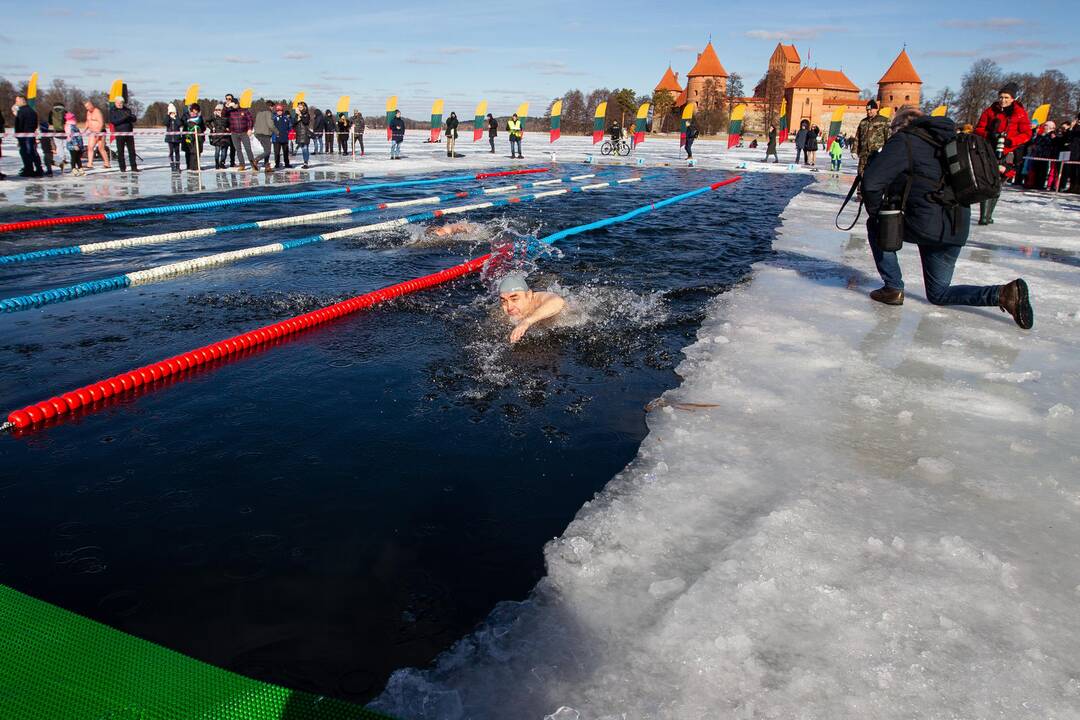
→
(0, 165, 806, 701)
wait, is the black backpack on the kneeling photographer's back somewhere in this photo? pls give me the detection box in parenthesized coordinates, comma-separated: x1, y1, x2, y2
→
(905, 127, 1001, 207)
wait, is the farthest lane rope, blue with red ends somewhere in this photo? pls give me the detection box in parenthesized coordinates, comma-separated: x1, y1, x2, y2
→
(0, 167, 551, 232)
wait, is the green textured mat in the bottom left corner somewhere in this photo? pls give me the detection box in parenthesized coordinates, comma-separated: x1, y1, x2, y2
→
(0, 585, 399, 720)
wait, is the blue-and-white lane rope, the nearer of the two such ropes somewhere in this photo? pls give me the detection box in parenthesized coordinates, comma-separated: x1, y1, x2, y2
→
(0, 177, 643, 312)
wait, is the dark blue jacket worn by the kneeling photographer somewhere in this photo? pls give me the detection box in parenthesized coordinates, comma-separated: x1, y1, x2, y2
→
(863, 118, 971, 245)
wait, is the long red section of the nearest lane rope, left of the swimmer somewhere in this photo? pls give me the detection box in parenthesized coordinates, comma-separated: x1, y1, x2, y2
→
(8, 253, 492, 430)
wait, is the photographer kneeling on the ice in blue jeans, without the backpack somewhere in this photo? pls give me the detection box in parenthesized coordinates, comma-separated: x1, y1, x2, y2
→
(862, 108, 1034, 329)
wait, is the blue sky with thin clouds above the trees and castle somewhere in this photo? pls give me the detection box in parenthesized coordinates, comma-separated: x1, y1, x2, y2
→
(0, 0, 1080, 117)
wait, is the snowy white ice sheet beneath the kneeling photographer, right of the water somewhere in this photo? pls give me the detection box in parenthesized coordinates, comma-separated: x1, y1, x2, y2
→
(376, 144, 1080, 720)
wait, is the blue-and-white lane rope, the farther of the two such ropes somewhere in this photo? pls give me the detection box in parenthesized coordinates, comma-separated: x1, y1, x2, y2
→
(0, 172, 606, 266)
